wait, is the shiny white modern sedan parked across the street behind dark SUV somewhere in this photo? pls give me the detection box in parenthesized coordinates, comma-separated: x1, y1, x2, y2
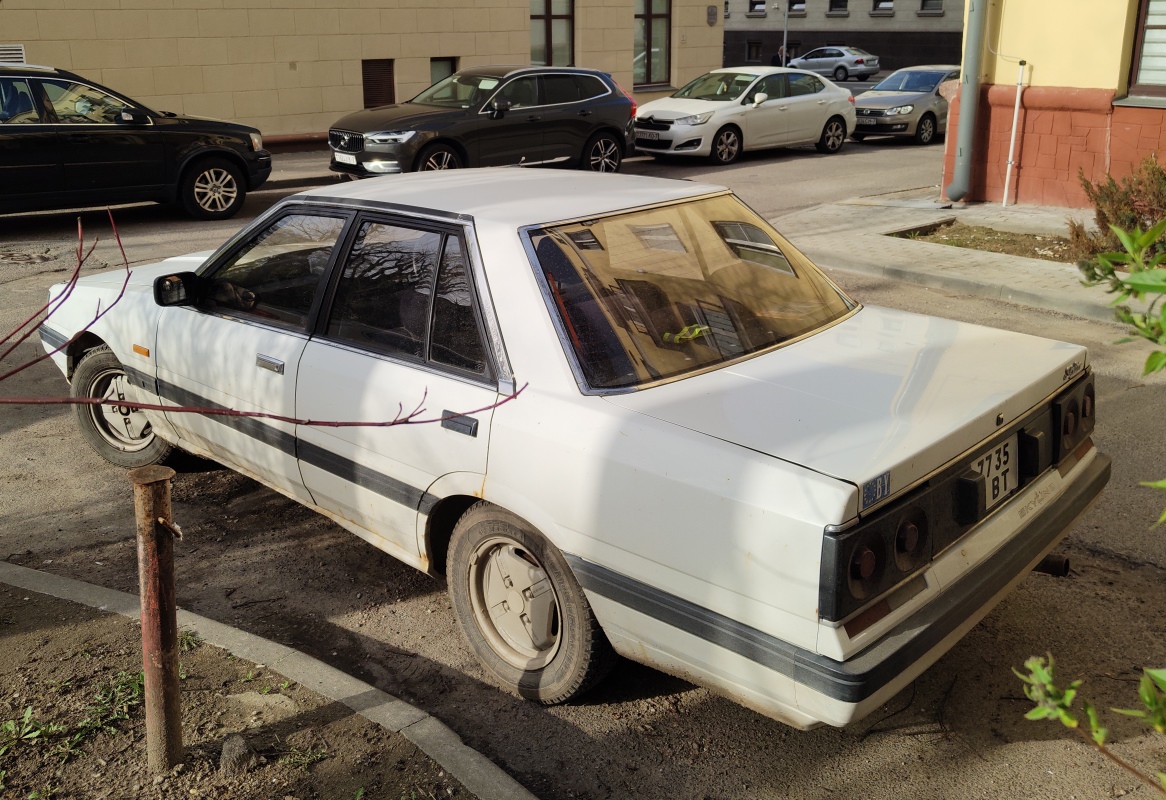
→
(635, 66, 855, 164)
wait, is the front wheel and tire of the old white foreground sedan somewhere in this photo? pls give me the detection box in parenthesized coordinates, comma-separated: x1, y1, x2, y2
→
(69, 344, 174, 469)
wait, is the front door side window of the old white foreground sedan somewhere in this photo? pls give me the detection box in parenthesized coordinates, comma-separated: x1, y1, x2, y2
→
(199, 213, 345, 328)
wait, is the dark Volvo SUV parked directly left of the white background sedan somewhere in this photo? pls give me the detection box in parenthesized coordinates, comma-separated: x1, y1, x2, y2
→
(328, 66, 635, 177)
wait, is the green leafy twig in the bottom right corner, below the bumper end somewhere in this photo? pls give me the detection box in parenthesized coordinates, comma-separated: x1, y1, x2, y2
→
(1012, 655, 1166, 795)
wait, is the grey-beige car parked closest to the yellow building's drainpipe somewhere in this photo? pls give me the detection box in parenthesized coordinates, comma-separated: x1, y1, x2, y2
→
(851, 64, 960, 145)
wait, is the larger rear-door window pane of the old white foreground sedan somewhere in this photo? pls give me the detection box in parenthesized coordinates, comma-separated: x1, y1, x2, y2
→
(328, 222, 442, 358)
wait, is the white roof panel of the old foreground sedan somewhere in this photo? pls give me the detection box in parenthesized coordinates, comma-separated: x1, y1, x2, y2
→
(295, 167, 728, 230)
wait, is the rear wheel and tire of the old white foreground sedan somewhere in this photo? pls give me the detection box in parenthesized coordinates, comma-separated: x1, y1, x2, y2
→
(447, 500, 616, 706)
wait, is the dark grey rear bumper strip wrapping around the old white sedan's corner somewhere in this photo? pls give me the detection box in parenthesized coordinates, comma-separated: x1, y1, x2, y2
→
(564, 452, 1110, 703)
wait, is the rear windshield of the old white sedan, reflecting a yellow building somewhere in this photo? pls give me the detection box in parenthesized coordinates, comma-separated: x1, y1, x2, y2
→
(531, 195, 855, 390)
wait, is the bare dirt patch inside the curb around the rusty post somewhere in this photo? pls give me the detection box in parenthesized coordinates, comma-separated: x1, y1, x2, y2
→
(0, 584, 472, 800)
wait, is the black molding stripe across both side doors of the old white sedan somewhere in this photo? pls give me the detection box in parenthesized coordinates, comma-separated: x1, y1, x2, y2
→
(157, 380, 441, 514)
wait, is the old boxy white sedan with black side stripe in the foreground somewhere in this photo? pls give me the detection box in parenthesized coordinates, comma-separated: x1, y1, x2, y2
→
(41, 169, 1110, 728)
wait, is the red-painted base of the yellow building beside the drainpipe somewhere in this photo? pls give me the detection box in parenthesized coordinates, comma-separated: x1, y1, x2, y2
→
(943, 84, 1166, 208)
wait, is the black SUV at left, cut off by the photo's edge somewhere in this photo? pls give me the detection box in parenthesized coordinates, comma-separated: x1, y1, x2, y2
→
(0, 64, 272, 219)
